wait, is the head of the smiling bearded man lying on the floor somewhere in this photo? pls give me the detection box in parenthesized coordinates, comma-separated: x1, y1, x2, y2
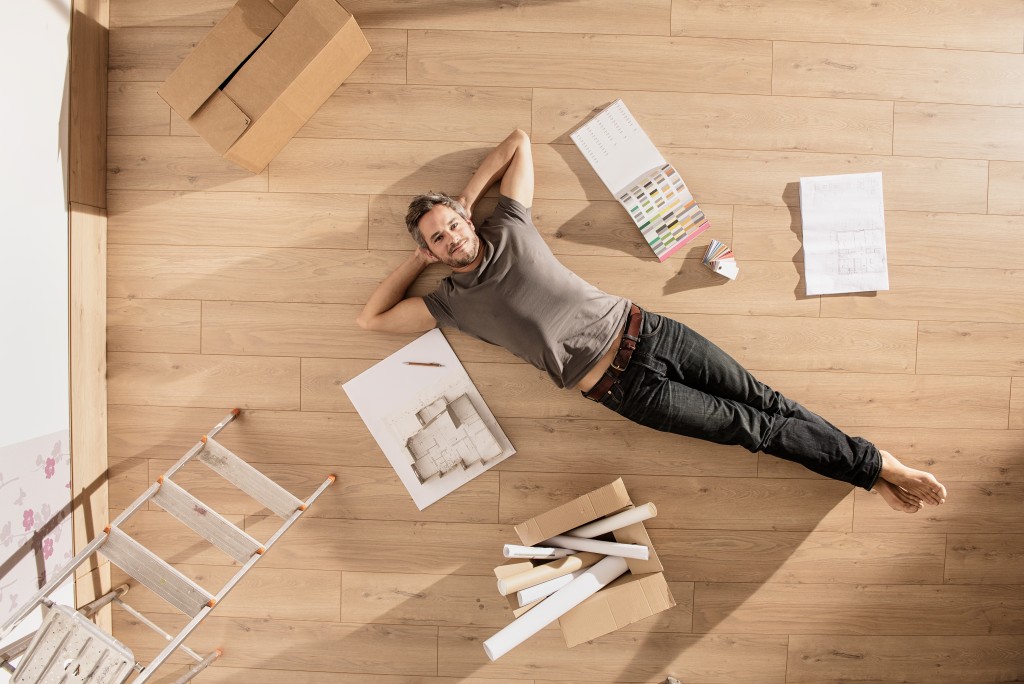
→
(406, 193, 480, 269)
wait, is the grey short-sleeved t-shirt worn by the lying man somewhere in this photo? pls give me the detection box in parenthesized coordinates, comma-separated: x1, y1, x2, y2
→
(424, 197, 630, 387)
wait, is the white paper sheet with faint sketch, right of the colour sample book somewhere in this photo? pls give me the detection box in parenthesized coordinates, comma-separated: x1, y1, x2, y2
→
(800, 172, 889, 296)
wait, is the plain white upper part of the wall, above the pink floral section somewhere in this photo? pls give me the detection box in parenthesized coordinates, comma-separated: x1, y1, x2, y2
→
(0, 0, 71, 446)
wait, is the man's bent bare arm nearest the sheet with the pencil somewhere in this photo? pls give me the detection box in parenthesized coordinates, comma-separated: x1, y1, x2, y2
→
(355, 250, 437, 333)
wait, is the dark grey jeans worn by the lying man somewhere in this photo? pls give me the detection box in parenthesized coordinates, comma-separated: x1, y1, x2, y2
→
(601, 311, 882, 489)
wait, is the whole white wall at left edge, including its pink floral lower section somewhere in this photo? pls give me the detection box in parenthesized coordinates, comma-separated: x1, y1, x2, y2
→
(0, 0, 71, 667)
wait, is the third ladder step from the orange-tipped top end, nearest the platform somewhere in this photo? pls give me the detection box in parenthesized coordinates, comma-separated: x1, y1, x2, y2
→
(99, 527, 213, 617)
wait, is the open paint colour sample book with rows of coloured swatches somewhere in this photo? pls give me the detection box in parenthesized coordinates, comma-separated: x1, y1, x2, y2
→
(570, 99, 710, 261)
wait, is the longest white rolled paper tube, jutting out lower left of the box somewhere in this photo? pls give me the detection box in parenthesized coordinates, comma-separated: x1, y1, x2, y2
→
(483, 556, 628, 660)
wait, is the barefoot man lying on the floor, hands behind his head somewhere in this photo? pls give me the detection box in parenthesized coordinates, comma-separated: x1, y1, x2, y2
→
(358, 130, 946, 513)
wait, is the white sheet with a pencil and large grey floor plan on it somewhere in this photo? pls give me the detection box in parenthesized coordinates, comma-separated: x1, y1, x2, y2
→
(342, 329, 515, 511)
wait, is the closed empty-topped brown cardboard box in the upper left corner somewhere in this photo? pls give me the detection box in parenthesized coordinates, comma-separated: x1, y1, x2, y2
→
(157, 0, 370, 173)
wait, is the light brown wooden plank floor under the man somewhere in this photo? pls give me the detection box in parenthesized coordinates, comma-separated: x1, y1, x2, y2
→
(108, 0, 1024, 684)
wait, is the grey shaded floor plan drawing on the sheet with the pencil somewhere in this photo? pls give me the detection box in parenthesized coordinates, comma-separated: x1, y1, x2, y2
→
(406, 394, 502, 482)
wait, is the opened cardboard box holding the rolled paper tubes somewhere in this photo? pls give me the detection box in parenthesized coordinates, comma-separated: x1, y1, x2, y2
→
(495, 478, 676, 647)
